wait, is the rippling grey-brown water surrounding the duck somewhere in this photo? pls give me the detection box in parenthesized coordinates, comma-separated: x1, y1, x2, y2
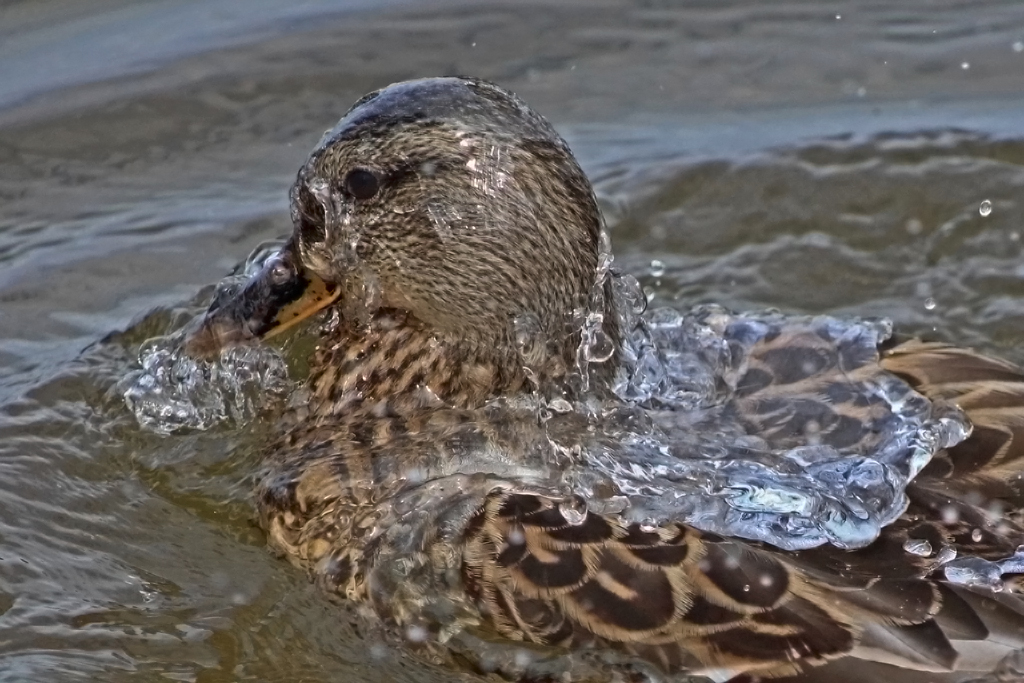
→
(0, 0, 1024, 683)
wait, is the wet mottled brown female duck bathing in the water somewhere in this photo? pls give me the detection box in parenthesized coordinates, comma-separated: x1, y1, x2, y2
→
(187, 78, 1024, 683)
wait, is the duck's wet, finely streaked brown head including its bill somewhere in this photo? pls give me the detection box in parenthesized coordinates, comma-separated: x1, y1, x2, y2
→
(186, 78, 617, 403)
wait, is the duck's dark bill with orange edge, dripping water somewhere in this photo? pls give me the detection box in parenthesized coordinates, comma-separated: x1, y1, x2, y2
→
(184, 242, 340, 358)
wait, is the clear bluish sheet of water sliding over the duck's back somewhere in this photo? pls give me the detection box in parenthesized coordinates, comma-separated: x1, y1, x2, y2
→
(566, 306, 970, 550)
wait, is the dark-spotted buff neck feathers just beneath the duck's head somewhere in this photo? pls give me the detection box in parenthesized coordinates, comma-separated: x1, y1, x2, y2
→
(307, 309, 528, 417)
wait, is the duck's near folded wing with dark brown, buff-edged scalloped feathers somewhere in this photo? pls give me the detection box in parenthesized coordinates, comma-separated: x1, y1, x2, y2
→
(463, 492, 1024, 683)
